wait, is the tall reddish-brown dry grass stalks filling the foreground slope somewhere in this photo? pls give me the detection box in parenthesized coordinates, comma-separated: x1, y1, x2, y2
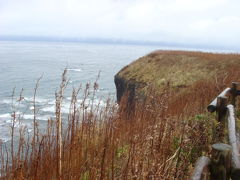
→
(0, 69, 240, 180)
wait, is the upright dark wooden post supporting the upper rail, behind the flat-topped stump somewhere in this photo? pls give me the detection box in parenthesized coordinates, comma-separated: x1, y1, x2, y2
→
(216, 96, 228, 142)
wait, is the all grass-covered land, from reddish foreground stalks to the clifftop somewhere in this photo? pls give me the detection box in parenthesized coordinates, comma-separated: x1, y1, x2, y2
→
(0, 51, 240, 180)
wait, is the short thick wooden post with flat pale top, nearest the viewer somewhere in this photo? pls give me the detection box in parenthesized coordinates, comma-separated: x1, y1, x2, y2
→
(210, 143, 231, 180)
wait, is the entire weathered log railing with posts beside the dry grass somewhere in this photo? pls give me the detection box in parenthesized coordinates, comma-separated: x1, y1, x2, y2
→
(191, 82, 240, 180)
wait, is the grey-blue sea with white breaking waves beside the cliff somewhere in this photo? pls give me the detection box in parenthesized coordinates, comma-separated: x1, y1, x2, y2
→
(0, 41, 236, 141)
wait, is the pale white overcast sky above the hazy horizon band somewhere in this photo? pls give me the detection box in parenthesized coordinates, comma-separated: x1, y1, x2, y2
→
(0, 0, 240, 47)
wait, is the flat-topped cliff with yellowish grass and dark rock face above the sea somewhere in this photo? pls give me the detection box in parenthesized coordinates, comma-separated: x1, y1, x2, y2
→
(114, 51, 240, 102)
